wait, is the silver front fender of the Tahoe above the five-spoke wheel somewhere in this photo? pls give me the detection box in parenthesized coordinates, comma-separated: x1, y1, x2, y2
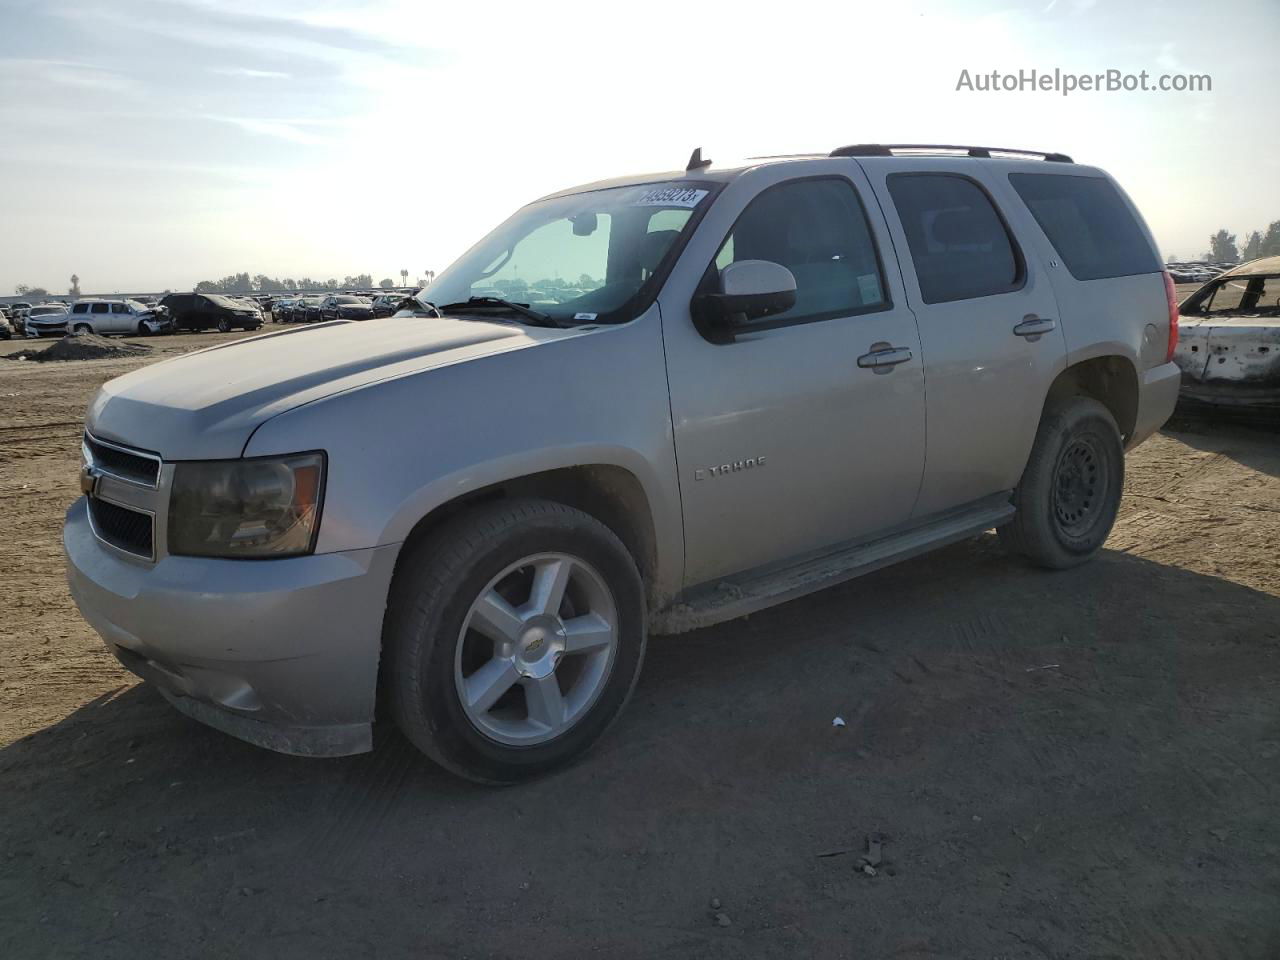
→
(244, 307, 684, 601)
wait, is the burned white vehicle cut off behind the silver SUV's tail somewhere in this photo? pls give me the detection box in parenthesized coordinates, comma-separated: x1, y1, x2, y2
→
(1174, 257, 1280, 411)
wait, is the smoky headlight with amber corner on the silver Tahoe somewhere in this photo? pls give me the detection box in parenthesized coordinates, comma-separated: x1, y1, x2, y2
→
(169, 453, 325, 558)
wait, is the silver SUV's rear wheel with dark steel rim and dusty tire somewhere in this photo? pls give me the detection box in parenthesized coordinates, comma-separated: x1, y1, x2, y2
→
(1000, 397, 1124, 570)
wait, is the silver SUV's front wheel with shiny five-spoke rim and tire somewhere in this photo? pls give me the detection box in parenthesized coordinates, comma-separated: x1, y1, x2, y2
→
(383, 500, 646, 783)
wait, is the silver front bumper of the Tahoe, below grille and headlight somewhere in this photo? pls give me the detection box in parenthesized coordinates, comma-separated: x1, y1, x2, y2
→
(63, 498, 399, 756)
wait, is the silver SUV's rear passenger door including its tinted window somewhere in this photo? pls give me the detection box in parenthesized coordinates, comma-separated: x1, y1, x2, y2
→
(860, 157, 1066, 518)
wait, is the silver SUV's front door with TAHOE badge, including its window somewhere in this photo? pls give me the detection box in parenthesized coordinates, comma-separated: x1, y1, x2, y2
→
(659, 160, 924, 585)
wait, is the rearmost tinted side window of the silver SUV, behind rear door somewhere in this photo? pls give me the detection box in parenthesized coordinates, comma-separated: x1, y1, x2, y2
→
(1009, 173, 1161, 280)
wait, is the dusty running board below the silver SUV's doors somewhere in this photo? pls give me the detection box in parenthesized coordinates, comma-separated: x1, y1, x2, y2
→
(650, 493, 1014, 634)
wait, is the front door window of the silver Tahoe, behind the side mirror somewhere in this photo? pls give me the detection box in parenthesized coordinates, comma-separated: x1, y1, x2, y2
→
(714, 178, 888, 326)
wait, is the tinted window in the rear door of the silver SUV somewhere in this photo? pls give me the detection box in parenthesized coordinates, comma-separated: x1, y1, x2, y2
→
(888, 173, 1024, 303)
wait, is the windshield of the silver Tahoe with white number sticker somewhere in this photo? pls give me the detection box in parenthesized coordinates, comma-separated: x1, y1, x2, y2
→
(417, 180, 719, 323)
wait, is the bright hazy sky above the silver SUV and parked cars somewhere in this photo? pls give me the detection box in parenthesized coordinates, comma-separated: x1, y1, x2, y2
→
(0, 0, 1280, 294)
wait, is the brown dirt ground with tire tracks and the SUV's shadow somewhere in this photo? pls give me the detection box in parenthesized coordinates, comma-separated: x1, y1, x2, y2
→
(0, 325, 1280, 960)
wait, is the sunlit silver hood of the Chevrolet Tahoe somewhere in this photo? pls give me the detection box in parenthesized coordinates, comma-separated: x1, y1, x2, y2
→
(86, 317, 555, 460)
